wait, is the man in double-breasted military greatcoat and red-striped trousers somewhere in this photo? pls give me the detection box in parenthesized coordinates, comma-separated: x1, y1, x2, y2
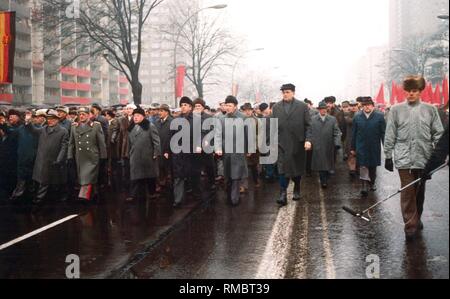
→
(68, 107, 107, 201)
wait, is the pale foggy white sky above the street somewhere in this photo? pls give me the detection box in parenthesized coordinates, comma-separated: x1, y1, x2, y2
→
(201, 0, 389, 102)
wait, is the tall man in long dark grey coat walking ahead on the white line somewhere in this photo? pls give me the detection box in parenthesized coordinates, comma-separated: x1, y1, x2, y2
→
(273, 84, 312, 206)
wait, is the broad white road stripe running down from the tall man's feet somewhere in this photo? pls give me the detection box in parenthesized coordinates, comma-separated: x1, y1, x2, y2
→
(256, 184, 298, 279)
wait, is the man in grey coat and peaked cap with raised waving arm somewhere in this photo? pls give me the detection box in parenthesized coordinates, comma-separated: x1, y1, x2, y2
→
(26, 110, 69, 204)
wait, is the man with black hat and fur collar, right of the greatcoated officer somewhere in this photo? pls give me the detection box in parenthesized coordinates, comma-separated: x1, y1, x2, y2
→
(127, 107, 161, 201)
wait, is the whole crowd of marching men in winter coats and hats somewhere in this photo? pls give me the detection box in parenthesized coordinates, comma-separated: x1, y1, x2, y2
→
(0, 77, 448, 238)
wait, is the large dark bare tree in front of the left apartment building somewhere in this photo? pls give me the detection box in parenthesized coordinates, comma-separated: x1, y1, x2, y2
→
(34, 0, 164, 104)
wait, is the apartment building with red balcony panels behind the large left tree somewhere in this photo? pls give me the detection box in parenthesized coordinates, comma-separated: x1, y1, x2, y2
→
(0, 0, 132, 106)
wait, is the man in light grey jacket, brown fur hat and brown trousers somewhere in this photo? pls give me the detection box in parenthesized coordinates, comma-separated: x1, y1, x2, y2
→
(384, 76, 444, 240)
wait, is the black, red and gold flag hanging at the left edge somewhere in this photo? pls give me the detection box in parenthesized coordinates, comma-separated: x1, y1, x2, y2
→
(0, 11, 16, 83)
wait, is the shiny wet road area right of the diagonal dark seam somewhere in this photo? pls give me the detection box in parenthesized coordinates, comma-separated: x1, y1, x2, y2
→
(128, 163, 449, 279)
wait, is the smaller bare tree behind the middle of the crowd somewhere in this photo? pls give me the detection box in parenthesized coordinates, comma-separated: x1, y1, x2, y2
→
(166, 2, 240, 98)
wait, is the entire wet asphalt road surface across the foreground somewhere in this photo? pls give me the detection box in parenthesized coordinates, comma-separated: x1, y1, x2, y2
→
(0, 158, 449, 279)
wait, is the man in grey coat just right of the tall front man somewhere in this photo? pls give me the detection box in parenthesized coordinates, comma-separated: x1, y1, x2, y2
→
(311, 102, 342, 188)
